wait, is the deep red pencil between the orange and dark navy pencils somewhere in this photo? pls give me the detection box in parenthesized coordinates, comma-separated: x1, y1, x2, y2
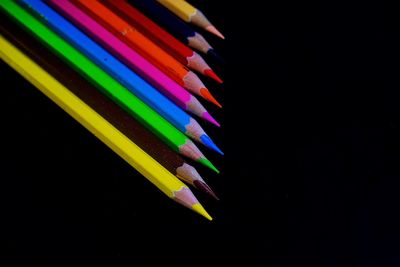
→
(101, 0, 222, 83)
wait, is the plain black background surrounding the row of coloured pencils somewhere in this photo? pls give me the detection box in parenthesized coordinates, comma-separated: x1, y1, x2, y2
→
(0, 0, 400, 267)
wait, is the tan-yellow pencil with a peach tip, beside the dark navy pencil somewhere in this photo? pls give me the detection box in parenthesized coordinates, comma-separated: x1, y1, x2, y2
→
(157, 0, 225, 39)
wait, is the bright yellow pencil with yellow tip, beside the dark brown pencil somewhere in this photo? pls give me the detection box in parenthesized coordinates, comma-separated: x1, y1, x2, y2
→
(0, 35, 212, 220)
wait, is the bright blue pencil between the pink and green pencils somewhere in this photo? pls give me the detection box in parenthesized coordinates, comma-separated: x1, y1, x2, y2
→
(18, 0, 222, 154)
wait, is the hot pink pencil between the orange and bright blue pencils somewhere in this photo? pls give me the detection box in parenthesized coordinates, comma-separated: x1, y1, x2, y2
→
(47, 0, 219, 126)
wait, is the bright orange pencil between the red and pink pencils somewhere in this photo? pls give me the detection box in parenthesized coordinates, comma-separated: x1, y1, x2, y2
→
(71, 0, 221, 107)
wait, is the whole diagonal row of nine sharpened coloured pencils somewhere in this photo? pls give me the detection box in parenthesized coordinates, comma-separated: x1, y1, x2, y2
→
(0, 0, 224, 220)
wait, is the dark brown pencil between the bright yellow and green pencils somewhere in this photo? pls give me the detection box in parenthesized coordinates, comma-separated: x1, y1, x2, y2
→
(0, 13, 218, 199)
